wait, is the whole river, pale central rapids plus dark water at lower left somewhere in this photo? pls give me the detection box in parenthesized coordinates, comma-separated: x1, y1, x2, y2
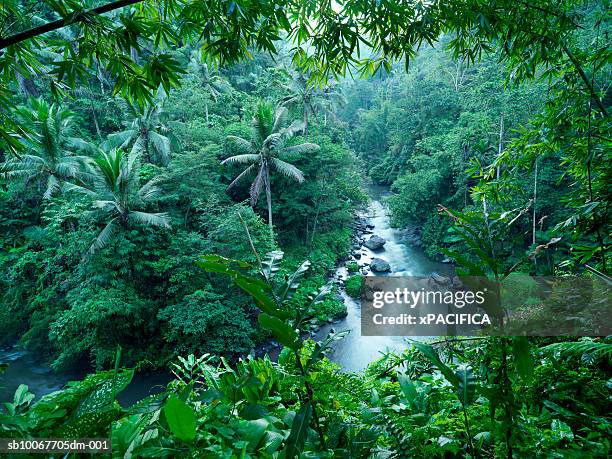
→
(0, 187, 450, 405)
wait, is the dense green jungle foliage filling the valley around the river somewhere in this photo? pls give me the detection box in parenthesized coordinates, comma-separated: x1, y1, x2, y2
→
(0, 0, 612, 458)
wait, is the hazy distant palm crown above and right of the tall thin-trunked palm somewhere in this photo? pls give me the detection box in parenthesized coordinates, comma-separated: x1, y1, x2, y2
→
(279, 73, 345, 134)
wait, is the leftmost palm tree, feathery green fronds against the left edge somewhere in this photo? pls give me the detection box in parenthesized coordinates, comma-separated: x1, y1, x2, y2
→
(0, 98, 92, 199)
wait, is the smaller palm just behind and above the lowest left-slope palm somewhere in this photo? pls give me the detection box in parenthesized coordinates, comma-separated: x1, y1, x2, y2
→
(104, 96, 177, 166)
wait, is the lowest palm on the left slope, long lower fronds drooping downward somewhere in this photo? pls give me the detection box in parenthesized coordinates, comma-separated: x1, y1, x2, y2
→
(68, 148, 170, 258)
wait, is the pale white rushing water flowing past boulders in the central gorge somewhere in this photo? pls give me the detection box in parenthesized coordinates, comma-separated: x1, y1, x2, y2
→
(315, 187, 451, 371)
